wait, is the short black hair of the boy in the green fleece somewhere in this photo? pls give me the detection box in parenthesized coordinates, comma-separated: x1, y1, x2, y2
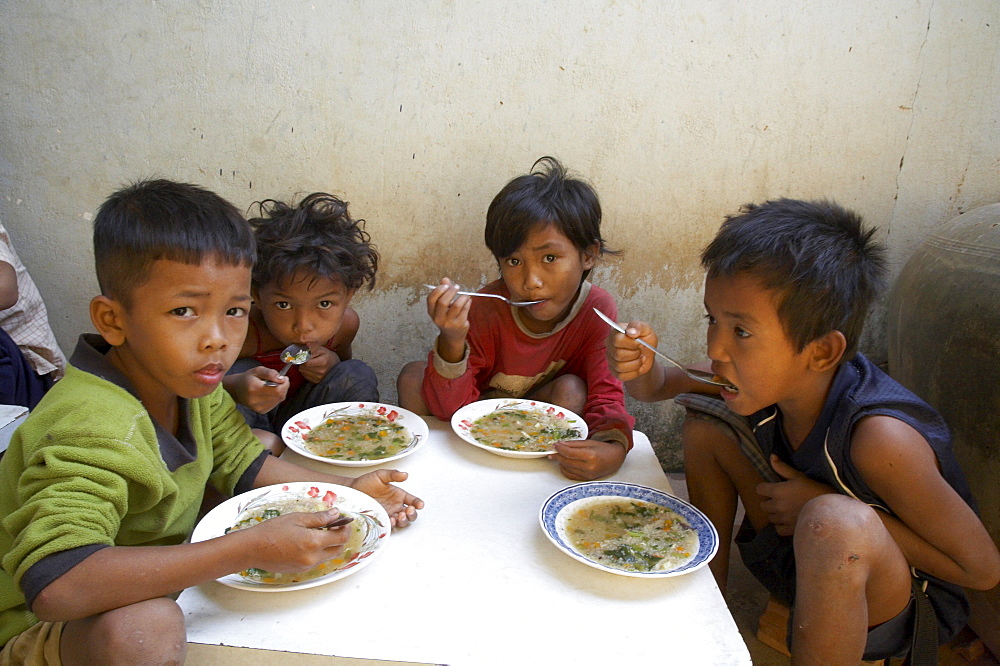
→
(94, 179, 256, 306)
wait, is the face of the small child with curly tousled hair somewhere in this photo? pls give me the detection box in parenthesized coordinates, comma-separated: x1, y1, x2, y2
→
(255, 271, 354, 349)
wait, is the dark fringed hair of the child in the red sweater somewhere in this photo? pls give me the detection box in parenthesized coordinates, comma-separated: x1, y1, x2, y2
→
(486, 157, 615, 268)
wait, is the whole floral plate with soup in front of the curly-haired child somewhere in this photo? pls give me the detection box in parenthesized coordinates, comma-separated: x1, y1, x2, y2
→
(281, 402, 429, 467)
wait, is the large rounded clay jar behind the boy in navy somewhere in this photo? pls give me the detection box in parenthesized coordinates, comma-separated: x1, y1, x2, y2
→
(887, 203, 1000, 654)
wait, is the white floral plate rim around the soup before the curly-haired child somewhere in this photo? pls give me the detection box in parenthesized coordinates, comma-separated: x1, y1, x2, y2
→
(281, 402, 430, 467)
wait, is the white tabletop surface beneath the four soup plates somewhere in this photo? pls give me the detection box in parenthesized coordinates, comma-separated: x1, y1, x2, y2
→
(178, 417, 751, 666)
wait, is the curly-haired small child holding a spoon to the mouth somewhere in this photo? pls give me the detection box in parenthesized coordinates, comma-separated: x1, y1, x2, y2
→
(224, 192, 379, 454)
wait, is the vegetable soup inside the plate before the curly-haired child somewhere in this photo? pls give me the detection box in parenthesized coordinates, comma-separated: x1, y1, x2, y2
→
(302, 414, 412, 460)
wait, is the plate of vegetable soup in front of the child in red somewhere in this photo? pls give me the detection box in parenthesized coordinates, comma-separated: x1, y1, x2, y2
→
(451, 398, 588, 458)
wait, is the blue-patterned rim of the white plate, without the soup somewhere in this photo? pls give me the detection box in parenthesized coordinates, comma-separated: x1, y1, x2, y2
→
(539, 481, 719, 578)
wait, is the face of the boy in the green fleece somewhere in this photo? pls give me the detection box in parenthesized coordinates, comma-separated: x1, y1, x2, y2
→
(99, 258, 250, 412)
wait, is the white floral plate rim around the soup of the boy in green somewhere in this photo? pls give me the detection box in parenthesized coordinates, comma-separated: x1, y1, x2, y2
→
(191, 482, 391, 592)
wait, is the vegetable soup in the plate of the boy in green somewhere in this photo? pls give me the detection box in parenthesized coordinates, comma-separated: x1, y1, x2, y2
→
(226, 488, 363, 585)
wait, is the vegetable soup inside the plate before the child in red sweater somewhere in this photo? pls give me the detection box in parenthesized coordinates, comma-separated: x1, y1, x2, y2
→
(469, 409, 580, 452)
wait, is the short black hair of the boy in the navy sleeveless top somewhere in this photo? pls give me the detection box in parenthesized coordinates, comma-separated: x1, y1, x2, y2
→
(701, 199, 886, 361)
